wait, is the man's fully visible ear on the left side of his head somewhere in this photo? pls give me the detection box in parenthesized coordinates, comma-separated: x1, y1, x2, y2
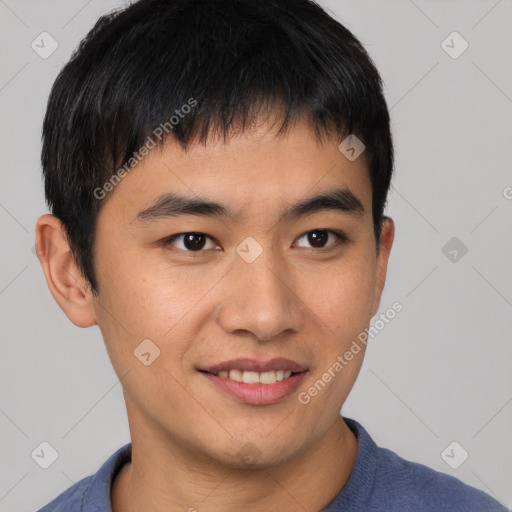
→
(36, 214, 96, 327)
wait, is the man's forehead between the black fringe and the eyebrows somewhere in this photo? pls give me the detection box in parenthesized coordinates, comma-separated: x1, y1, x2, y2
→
(100, 123, 371, 225)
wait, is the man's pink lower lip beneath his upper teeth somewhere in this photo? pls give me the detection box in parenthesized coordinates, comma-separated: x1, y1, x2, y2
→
(200, 372, 307, 405)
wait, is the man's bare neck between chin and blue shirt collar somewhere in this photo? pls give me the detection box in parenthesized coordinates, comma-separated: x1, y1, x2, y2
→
(111, 406, 358, 512)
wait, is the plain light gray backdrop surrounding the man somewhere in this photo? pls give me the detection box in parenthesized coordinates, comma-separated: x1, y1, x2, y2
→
(0, 0, 512, 512)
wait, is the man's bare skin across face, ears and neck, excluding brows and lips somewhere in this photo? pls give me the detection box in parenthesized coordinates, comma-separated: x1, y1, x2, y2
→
(36, 118, 394, 512)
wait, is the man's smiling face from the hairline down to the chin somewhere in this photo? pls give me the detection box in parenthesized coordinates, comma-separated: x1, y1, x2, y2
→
(41, 119, 392, 465)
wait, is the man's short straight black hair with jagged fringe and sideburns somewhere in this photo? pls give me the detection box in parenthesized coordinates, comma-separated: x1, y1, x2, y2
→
(41, 0, 393, 293)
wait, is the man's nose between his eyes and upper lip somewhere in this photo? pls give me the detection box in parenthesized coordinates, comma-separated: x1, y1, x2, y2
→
(217, 249, 304, 341)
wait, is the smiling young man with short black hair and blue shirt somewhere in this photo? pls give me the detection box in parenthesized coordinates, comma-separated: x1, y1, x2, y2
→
(36, 0, 504, 512)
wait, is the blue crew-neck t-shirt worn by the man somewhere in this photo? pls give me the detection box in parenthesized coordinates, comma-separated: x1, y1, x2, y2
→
(38, 418, 508, 512)
